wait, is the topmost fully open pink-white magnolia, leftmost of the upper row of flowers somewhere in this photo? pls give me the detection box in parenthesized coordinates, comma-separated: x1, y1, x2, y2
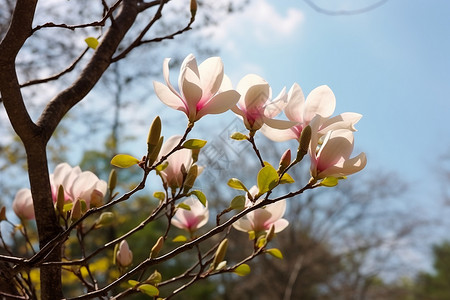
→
(153, 54, 239, 122)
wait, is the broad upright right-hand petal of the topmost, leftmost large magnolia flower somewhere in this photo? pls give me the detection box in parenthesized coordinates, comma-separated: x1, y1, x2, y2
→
(198, 57, 223, 97)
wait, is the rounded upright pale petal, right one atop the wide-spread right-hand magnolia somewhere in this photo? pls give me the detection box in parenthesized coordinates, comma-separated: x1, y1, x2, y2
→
(303, 85, 336, 123)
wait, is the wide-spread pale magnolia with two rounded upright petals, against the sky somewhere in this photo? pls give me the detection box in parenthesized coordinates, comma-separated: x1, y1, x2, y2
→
(261, 83, 361, 142)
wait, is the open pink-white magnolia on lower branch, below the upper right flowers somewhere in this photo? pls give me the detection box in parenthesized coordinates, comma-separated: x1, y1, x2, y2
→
(233, 186, 289, 235)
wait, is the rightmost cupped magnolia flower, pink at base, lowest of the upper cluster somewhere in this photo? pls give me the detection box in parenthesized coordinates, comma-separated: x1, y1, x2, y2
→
(309, 118, 367, 180)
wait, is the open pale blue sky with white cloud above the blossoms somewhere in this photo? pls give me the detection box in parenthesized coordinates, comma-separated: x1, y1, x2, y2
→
(196, 0, 450, 204)
